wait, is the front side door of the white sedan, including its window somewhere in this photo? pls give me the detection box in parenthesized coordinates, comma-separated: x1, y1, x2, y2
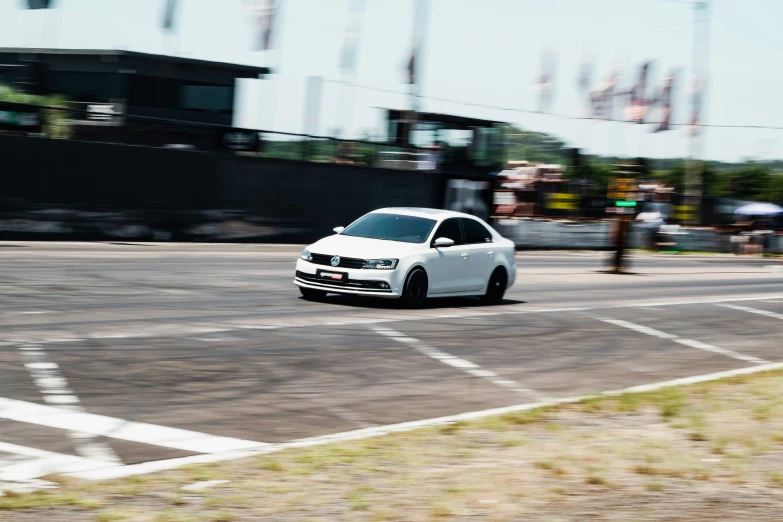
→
(429, 218, 468, 294)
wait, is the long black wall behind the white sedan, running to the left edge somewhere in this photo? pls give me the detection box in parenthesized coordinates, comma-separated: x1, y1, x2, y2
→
(0, 135, 491, 242)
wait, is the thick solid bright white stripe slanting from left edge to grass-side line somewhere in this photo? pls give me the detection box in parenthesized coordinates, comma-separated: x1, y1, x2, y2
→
(0, 398, 267, 453)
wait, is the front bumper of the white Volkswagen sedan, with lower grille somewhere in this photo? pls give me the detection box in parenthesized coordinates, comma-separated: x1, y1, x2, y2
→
(294, 259, 405, 298)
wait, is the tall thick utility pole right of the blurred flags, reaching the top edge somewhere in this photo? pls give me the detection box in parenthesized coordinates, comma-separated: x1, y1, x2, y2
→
(685, 0, 710, 223)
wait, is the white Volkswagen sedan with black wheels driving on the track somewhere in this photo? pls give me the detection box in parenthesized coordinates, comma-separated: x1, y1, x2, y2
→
(294, 208, 517, 308)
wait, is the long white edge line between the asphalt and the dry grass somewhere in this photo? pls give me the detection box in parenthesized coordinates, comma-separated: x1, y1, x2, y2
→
(69, 363, 783, 480)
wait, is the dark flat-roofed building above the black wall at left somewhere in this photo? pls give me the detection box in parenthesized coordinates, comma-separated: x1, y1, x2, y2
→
(0, 48, 269, 150)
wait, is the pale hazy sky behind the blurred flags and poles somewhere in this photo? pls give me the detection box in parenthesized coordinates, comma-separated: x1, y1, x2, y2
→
(0, 0, 783, 161)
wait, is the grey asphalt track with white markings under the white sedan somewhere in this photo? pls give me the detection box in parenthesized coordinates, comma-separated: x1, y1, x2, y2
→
(0, 243, 783, 482)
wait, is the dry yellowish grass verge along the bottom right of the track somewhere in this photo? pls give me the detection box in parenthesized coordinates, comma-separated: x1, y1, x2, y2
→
(0, 372, 783, 522)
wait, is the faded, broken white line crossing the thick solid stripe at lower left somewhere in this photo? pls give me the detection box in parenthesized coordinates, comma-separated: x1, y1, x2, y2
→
(19, 345, 122, 464)
